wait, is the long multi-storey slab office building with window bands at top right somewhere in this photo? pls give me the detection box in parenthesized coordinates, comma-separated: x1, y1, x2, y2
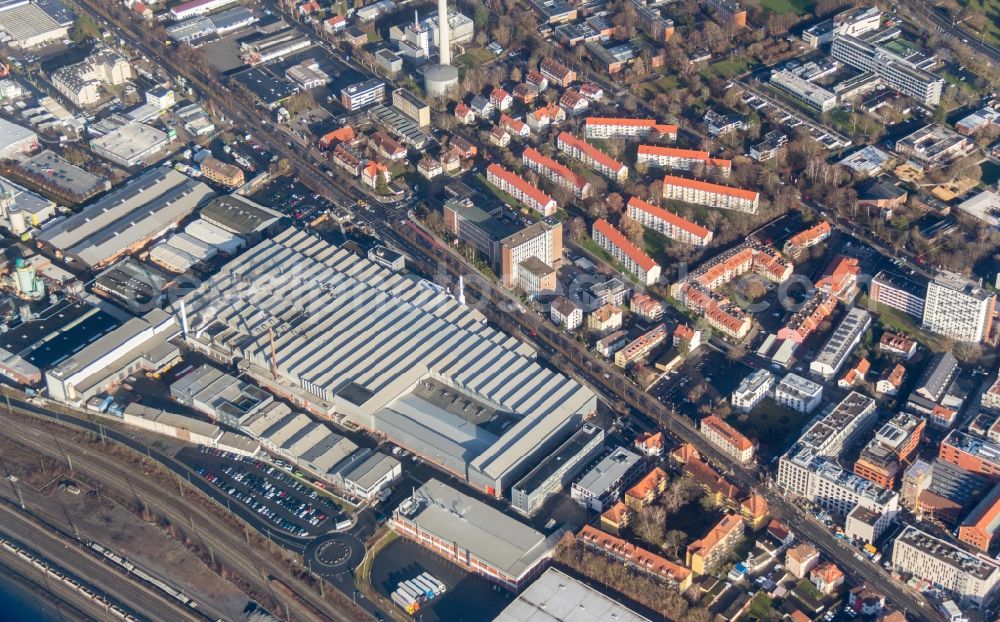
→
(830, 34, 944, 106)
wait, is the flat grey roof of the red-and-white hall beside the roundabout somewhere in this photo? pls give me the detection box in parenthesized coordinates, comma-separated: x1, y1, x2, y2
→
(400, 479, 556, 577)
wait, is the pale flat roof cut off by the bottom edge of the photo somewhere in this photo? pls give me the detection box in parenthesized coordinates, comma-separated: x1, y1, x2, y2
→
(493, 568, 649, 622)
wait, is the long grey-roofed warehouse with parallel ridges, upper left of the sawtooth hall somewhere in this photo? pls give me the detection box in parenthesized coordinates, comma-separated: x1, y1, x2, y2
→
(37, 166, 215, 268)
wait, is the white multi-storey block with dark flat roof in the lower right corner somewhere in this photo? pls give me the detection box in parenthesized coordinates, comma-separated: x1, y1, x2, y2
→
(892, 525, 1000, 604)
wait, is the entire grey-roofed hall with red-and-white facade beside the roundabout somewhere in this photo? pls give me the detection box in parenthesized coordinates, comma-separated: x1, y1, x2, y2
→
(391, 479, 562, 592)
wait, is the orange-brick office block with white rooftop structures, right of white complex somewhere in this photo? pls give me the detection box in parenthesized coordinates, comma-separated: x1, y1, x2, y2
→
(854, 413, 927, 489)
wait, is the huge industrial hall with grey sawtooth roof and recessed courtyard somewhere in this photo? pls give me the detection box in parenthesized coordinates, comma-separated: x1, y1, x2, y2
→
(174, 229, 597, 496)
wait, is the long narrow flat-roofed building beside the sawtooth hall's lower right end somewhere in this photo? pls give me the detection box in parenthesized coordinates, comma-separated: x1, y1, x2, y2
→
(510, 423, 604, 515)
